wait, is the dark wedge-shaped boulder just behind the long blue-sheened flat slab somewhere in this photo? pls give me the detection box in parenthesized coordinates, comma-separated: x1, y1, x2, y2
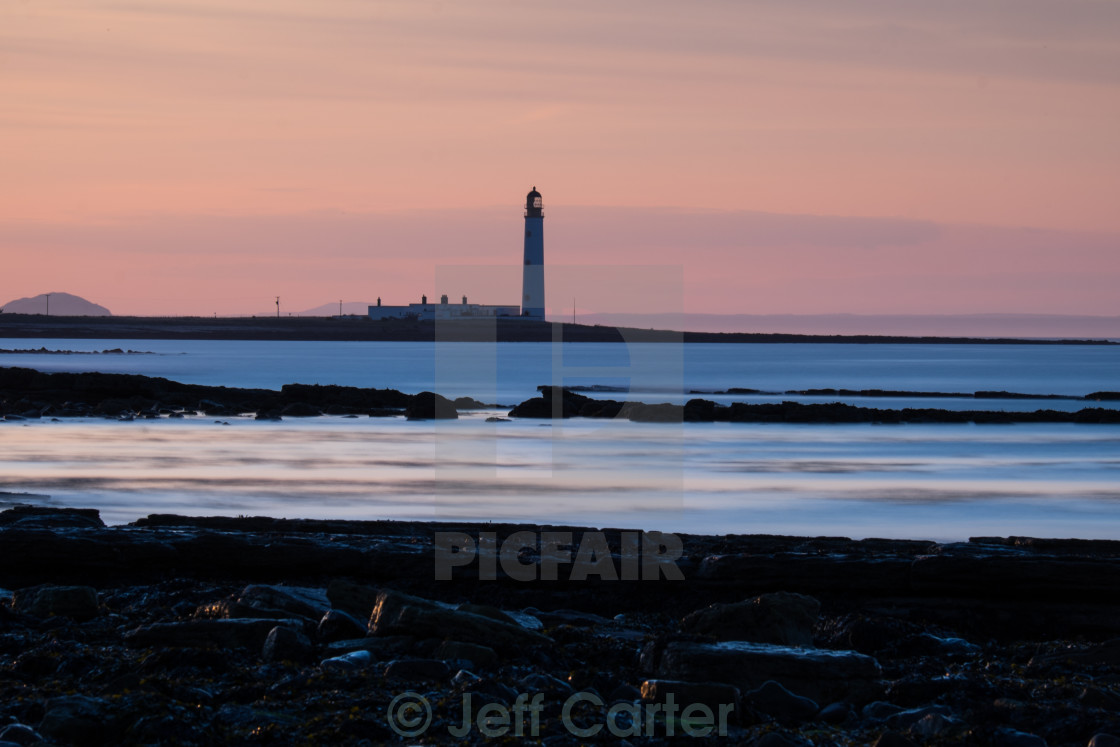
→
(681, 591, 821, 646)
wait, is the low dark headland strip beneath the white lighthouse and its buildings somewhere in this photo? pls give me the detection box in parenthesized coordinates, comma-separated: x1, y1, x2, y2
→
(0, 314, 1117, 345)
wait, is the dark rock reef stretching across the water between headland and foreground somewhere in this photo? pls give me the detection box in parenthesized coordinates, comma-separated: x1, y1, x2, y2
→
(0, 367, 1120, 423)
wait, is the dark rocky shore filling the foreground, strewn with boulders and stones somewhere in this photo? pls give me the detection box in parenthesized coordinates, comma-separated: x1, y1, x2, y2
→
(0, 506, 1120, 747)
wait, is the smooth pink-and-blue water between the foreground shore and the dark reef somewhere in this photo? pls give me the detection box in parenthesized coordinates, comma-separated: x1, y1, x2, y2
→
(0, 413, 1120, 540)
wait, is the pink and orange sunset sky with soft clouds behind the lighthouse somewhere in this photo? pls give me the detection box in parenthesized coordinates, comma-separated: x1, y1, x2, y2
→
(0, 0, 1120, 315)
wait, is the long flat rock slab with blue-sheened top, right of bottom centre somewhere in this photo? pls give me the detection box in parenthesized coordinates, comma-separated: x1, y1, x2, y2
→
(655, 641, 883, 703)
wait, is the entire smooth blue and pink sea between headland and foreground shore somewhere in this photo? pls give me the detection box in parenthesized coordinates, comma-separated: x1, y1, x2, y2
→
(0, 339, 1120, 541)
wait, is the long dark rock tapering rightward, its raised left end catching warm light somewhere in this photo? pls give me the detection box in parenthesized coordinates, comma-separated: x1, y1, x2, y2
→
(370, 591, 550, 647)
